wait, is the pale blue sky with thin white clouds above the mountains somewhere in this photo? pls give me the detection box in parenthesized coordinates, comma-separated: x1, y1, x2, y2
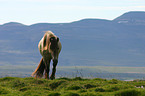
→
(0, 0, 145, 25)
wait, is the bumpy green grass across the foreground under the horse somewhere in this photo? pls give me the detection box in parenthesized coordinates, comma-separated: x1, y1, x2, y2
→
(0, 77, 145, 96)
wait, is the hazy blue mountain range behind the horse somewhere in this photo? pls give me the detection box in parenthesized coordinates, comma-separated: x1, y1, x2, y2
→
(0, 11, 145, 67)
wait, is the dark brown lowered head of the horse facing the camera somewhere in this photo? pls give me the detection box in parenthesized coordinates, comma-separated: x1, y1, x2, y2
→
(49, 37, 59, 63)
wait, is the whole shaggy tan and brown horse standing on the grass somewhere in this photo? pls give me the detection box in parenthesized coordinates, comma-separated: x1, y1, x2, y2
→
(32, 31, 62, 80)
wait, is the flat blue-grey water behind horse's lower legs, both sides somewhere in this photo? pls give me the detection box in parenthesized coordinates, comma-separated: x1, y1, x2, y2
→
(0, 70, 145, 80)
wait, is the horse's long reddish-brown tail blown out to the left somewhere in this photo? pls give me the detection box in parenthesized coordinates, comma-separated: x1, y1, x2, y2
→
(31, 58, 45, 78)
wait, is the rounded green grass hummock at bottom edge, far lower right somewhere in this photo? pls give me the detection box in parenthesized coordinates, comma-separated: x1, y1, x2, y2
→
(115, 89, 140, 96)
